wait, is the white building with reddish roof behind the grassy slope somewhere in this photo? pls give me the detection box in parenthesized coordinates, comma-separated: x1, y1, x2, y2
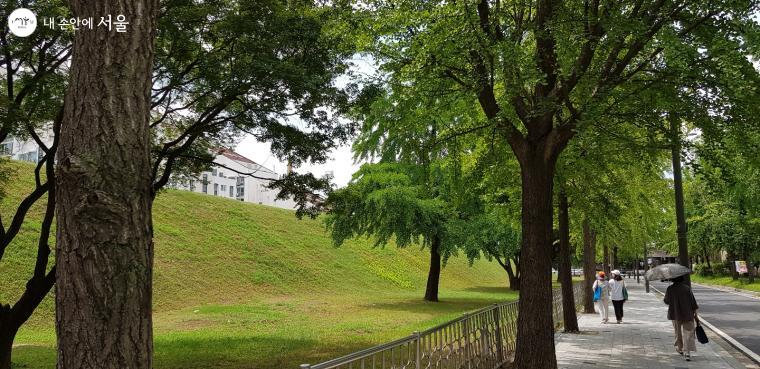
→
(171, 149, 296, 209)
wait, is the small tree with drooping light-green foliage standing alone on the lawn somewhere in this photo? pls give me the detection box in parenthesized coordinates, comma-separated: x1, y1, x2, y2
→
(325, 163, 453, 301)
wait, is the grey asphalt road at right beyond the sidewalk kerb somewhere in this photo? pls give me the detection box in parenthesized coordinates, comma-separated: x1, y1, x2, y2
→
(652, 282, 760, 355)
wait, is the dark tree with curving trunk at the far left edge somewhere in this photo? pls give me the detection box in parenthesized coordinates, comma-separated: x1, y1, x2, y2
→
(0, 1, 71, 369)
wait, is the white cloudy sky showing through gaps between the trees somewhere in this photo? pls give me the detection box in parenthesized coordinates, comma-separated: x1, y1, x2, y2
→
(235, 55, 377, 187)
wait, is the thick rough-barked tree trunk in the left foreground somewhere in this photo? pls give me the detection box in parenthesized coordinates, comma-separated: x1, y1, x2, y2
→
(56, 0, 158, 369)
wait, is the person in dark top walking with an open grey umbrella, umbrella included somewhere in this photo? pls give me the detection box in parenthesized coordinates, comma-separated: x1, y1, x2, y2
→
(647, 264, 699, 361)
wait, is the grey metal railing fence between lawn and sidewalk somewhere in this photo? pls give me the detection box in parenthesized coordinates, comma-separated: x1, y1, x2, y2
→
(301, 282, 586, 369)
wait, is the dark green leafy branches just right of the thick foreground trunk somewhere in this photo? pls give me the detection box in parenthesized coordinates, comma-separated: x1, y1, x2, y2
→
(150, 0, 360, 216)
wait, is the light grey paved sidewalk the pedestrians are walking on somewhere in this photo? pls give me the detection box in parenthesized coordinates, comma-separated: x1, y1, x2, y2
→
(556, 279, 744, 369)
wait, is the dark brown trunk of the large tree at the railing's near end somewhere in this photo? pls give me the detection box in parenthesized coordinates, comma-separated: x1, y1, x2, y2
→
(515, 157, 557, 369)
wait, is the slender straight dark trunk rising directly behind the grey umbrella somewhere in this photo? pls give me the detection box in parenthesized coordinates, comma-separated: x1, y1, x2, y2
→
(670, 116, 691, 285)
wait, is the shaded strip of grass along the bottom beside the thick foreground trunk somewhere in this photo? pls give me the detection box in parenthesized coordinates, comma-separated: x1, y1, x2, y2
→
(12, 333, 377, 369)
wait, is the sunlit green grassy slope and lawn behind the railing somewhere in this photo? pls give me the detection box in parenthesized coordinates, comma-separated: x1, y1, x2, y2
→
(0, 163, 517, 369)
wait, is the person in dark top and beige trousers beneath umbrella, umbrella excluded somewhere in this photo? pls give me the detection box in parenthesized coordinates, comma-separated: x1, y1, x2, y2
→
(664, 276, 699, 361)
